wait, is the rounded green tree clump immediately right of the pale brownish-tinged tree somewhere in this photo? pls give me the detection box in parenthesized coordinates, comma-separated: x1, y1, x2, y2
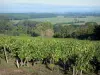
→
(54, 25, 75, 38)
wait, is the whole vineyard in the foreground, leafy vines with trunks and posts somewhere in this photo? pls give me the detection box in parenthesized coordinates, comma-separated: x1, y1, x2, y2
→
(0, 36, 100, 75)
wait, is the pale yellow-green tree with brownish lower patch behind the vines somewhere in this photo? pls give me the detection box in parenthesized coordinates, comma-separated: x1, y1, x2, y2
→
(34, 22, 53, 37)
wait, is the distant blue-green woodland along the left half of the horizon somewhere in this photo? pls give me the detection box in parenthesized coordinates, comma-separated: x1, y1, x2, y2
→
(0, 13, 57, 20)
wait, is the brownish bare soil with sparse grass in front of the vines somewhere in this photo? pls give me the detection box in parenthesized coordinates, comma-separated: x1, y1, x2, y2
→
(0, 60, 100, 75)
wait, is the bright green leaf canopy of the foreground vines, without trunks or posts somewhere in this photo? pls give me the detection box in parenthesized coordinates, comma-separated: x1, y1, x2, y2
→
(0, 36, 100, 72)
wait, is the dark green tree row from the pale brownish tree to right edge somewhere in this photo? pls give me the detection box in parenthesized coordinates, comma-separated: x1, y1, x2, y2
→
(54, 22, 99, 40)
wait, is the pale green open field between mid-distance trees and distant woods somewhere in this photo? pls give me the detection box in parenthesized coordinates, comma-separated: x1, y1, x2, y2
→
(15, 16, 100, 25)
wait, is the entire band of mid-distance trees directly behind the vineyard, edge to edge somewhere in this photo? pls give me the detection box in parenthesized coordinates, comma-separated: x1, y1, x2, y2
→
(0, 16, 100, 40)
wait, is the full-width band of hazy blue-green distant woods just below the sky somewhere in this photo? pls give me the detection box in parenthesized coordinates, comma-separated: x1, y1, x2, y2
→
(0, 12, 100, 20)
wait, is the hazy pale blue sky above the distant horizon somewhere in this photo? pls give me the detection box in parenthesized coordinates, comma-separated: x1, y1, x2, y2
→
(0, 0, 100, 12)
